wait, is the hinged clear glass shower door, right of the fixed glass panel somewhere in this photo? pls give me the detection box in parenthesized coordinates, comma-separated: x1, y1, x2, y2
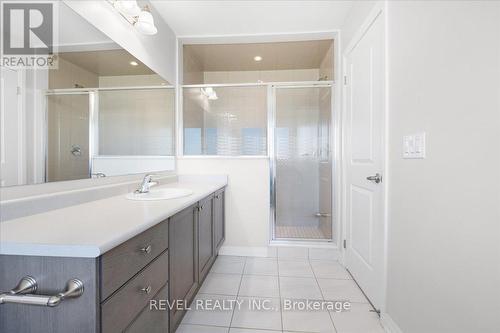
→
(273, 86, 333, 241)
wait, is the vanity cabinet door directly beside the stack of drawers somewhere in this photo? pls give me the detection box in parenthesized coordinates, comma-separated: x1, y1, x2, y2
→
(168, 206, 198, 332)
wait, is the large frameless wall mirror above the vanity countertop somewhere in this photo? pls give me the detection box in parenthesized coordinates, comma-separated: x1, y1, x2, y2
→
(0, 2, 175, 187)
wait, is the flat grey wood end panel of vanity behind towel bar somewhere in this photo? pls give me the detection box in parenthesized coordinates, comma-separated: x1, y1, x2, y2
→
(0, 255, 100, 333)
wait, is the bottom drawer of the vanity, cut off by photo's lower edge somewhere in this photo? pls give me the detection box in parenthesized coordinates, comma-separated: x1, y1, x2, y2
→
(125, 284, 168, 333)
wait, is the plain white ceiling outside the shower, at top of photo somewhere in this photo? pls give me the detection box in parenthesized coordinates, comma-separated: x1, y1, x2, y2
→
(152, 0, 353, 37)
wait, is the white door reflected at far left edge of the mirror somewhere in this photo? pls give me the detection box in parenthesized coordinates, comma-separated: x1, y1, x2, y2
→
(0, 67, 24, 186)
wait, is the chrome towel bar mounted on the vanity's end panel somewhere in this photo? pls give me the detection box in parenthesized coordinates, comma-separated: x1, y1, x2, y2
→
(0, 276, 83, 307)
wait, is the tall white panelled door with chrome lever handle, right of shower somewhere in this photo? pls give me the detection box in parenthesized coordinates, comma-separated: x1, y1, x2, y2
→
(344, 14, 385, 309)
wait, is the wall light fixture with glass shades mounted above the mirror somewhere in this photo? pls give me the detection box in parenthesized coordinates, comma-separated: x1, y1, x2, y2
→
(108, 0, 158, 35)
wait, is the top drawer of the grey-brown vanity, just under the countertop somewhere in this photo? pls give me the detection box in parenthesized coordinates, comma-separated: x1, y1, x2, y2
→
(101, 221, 168, 302)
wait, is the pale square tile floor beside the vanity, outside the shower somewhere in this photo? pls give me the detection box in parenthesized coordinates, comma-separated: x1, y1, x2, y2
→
(177, 255, 384, 333)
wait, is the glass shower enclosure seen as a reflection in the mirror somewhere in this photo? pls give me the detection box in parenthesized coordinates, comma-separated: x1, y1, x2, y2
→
(43, 86, 175, 182)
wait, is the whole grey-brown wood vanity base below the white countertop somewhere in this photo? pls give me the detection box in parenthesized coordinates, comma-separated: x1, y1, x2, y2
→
(0, 189, 225, 333)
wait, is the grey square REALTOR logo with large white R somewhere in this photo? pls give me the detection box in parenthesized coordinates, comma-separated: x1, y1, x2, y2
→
(1, 1, 55, 68)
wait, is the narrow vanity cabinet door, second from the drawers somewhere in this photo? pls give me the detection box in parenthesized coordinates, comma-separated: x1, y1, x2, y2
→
(198, 196, 215, 281)
